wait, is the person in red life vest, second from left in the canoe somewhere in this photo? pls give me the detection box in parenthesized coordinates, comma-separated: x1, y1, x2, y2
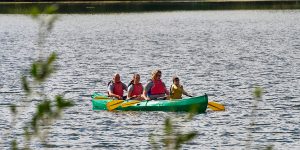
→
(127, 74, 144, 100)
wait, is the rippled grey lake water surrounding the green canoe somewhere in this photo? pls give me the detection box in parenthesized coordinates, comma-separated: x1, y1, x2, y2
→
(0, 10, 300, 149)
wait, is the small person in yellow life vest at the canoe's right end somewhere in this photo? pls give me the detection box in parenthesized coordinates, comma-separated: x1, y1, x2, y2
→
(170, 76, 193, 99)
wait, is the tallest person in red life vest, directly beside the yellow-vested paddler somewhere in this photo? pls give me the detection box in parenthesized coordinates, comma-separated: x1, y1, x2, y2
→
(143, 70, 170, 100)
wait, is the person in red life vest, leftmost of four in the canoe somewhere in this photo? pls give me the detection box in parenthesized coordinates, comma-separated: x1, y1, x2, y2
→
(107, 74, 127, 99)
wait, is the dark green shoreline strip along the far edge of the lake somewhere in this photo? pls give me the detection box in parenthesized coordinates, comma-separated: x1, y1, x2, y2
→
(0, 0, 300, 14)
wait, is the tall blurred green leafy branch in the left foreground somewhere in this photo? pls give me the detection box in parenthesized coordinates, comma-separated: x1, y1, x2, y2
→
(14, 5, 74, 149)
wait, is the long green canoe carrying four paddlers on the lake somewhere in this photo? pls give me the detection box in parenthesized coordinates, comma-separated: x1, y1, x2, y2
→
(92, 93, 208, 113)
